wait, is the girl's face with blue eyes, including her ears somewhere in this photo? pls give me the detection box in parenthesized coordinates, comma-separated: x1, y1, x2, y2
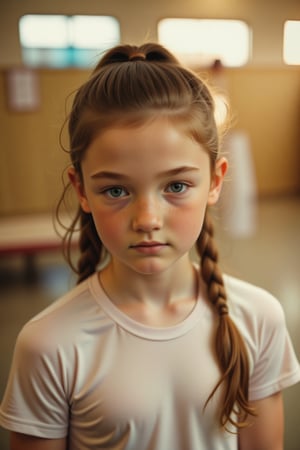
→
(69, 117, 227, 274)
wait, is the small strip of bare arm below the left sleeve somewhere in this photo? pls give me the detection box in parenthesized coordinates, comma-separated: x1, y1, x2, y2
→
(10, 432, 67, 450)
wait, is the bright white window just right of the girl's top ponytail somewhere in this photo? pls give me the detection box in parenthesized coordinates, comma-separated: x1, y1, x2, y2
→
(158, 19, 251, 67)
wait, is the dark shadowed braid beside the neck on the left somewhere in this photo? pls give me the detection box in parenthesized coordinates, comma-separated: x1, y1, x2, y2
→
(77, 211, 102, 284)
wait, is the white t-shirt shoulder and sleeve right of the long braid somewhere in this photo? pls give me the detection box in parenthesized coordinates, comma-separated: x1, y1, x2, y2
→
(225, 276, 300, 401)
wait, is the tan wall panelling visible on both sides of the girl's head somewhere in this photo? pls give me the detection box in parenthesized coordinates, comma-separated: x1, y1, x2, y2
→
(0, 68, 300, 214)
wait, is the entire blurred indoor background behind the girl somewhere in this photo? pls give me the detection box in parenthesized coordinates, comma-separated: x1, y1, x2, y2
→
(0, 0, 300, 450)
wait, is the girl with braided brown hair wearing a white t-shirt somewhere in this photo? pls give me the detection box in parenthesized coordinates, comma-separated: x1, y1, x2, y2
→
(1, 44, 300, 450)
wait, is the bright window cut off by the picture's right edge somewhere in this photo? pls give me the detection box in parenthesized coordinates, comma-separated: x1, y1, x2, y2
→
(283, 20, 300, 64)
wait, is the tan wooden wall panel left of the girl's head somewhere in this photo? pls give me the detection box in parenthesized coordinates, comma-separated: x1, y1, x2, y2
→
(0, 70, 88, 214)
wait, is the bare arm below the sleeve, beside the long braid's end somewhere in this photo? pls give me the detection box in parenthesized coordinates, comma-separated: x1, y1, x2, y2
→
(239, 392, 284, 450)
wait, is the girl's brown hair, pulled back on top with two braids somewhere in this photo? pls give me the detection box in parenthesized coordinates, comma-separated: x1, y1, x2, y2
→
(61, 43, 253, 427)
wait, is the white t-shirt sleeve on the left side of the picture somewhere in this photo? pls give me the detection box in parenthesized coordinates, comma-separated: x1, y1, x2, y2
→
(0, 323, 69, 439)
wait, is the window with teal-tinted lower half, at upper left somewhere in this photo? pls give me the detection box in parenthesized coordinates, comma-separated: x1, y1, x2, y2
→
(19, 14, 120, 67)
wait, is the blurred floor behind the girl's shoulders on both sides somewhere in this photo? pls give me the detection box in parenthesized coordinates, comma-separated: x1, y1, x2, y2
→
(0, 197, 300, 450)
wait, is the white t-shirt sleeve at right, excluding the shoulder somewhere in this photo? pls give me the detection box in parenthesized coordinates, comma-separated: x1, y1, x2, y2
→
(249, 291, 300, 401)
